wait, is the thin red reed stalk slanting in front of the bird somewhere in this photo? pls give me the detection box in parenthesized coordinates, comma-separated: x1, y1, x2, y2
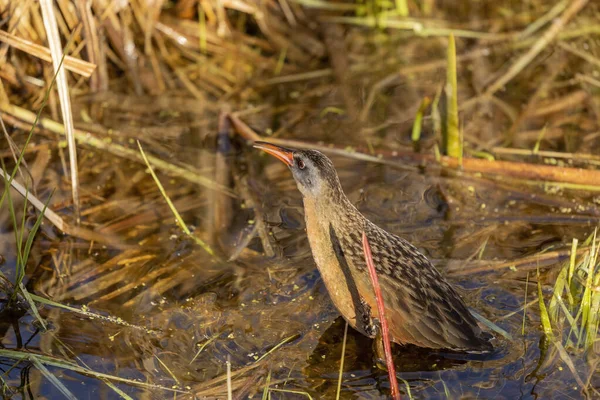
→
(362, 231, 400, 400)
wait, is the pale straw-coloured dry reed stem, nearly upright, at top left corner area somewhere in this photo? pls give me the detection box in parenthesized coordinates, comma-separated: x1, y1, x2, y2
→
(40, 0, 81, 225)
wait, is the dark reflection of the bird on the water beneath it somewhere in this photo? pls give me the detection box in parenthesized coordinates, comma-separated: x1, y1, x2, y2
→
(303, 317, 510, 398)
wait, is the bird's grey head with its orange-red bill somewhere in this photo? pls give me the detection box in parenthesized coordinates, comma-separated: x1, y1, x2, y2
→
(254, 142, 342, 199)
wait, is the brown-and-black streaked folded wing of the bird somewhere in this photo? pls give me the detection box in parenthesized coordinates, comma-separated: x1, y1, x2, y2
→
(344, 224, 490, 350)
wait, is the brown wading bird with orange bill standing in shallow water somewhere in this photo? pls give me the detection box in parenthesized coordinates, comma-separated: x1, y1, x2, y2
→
(254, 142, 492, 352)
